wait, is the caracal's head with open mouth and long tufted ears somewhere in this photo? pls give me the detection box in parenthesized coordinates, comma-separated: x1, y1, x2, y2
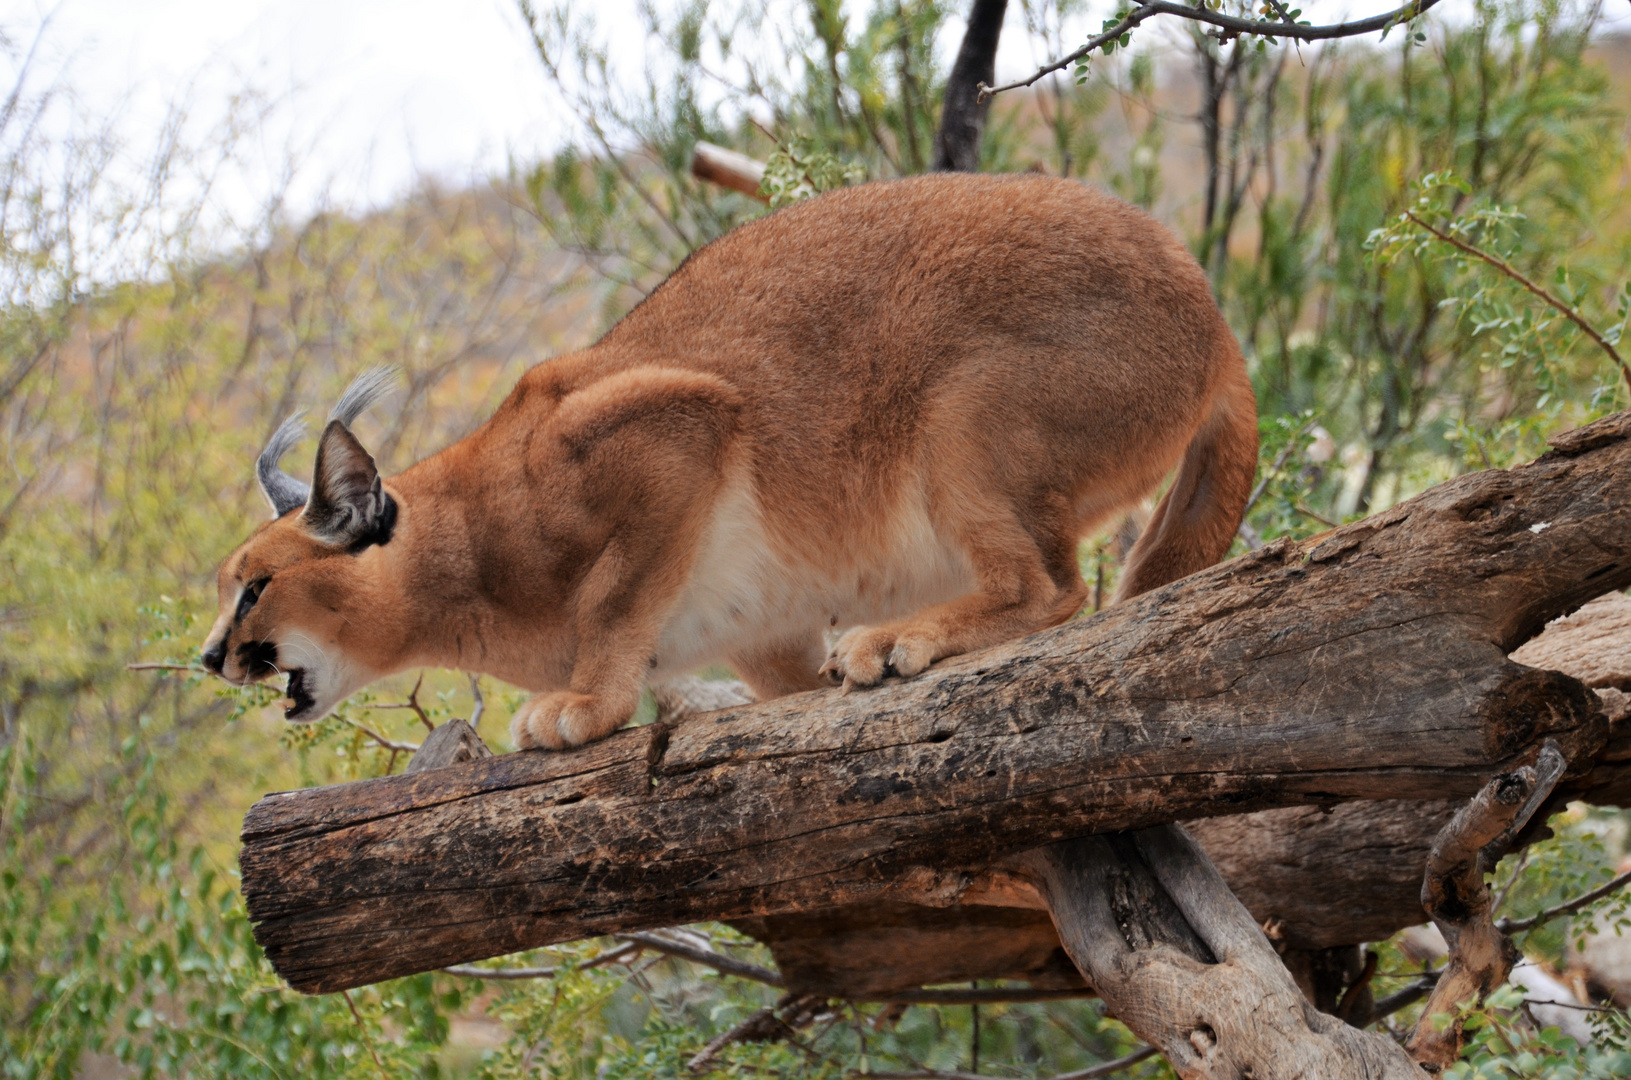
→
(204, 369, 396, 723)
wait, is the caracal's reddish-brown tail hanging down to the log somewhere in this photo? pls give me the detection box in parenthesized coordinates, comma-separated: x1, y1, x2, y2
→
(1116, 347, 1258, 602)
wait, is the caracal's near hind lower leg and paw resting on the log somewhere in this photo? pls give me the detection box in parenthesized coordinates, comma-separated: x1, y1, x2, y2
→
(820, 489, 1088, 690)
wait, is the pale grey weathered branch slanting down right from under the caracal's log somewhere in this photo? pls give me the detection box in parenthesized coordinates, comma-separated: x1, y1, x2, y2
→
(1026, 825, 1422, 1080)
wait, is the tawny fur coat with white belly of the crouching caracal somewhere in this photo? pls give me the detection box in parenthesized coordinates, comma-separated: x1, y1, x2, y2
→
(197, 175, 1258, 747)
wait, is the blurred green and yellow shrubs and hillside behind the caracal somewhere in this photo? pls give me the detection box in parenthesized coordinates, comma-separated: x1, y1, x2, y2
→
(0, 0, 1631, 1078)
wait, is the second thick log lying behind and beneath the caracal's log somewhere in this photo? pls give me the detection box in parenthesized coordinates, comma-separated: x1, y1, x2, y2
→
(734, 642, 1631, 1004)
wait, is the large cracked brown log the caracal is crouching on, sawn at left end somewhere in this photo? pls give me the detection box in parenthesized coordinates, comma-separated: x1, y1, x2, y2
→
(241, 414, 1631, 992)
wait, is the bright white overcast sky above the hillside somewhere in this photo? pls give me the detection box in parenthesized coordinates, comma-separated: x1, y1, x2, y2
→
(0, 0, 1624, 226)
